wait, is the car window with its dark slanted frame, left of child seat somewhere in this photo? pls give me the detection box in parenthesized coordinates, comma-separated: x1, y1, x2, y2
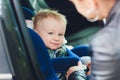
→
(0, 0, 43, 80)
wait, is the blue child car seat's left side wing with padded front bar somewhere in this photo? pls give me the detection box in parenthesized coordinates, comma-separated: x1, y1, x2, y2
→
(28, 28, 80, 80)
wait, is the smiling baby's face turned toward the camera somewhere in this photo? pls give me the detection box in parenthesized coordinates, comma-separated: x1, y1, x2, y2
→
(36, 17, 66, 50)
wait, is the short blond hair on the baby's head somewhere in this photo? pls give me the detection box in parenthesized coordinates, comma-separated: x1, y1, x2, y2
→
(33, 9, 67, 29)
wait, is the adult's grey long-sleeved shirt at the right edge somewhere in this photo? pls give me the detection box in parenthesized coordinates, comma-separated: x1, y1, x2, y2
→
(90, 0, 120, 80)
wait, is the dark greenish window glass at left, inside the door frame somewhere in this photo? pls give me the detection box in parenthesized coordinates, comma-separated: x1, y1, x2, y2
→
(0, 0, 42, 80)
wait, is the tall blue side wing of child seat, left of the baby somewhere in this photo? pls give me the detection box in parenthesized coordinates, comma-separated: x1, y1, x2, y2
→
(28, 28, 58, 80)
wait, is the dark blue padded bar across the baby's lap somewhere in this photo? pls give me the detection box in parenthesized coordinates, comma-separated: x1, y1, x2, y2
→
(51, 56, 79, 73)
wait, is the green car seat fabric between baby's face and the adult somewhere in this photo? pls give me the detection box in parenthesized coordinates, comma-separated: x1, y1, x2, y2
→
(66, 27, 102, 47)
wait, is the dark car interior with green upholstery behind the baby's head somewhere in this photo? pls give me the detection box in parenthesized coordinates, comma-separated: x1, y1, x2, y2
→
(20, 0, 103, 47)
